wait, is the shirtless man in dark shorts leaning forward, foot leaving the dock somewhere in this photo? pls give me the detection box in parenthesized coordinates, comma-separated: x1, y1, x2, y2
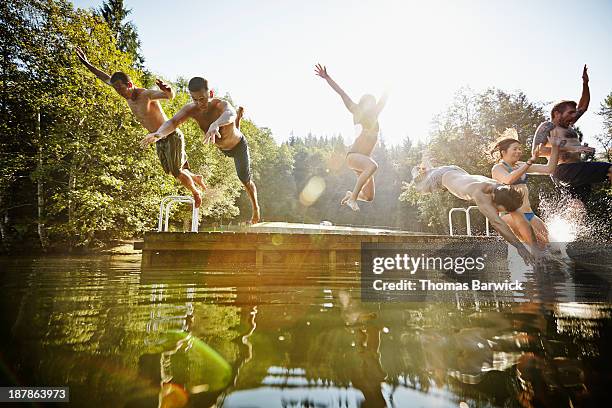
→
(141, 77, 260, 224)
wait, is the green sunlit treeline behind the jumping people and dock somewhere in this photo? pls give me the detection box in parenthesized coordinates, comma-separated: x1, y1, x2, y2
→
(0, 0, 612, 251)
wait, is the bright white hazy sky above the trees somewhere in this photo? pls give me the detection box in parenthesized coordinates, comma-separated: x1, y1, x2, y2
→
(74, 0, 612, 146)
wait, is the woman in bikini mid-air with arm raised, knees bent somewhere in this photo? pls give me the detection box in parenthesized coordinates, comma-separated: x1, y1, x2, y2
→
(315, 64, 387, 211)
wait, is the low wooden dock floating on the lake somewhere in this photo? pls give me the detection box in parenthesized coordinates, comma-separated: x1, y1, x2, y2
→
(140, 222, 498, 268)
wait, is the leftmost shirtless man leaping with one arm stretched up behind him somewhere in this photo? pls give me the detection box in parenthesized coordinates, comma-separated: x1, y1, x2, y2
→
(76, 48, 206, 208)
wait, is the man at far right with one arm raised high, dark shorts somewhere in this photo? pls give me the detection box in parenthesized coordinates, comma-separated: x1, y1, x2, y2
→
(532, 65, 612, 200)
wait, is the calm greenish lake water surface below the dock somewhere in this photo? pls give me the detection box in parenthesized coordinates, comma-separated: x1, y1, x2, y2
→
(0, 256, 612, 408)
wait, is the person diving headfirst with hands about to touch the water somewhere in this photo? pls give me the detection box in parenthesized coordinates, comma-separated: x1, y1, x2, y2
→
(414, 165, 536, 264)
